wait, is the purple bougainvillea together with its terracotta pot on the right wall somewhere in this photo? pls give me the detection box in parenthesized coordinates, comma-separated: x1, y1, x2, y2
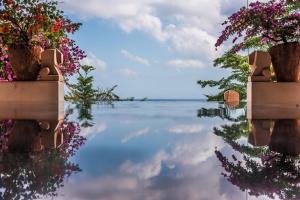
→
(215, 0, 300, 82)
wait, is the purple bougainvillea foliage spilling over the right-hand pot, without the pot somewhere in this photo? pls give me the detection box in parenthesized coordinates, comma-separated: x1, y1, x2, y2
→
(215, 0, 300, 52)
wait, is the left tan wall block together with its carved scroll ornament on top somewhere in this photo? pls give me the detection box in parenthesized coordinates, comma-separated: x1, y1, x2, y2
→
(0, 49, 64, 119)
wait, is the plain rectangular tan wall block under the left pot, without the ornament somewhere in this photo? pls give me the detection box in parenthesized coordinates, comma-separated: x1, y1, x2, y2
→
(0, 81, 64, 120)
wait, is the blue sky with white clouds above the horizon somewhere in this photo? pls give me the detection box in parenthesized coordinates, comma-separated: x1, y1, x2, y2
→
(61, 0, 252, 99)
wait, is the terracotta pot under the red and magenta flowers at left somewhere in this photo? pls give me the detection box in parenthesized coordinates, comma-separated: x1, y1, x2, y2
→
(9, 45, 42, 81)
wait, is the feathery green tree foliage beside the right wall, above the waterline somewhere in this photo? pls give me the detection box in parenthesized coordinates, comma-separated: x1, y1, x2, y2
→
(198, 52, 249, 101)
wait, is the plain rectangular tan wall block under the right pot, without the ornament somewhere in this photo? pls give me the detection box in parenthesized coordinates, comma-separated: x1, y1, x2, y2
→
(247, 82, 300, 119)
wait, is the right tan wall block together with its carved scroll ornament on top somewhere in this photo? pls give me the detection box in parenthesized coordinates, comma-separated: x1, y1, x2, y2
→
(247, 52, 300, 119)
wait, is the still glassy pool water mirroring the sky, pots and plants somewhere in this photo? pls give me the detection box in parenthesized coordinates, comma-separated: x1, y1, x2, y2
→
(0, 101, 300, 200)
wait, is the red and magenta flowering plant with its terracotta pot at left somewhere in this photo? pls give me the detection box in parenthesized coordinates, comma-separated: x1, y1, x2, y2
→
(0, 0, 85, 81)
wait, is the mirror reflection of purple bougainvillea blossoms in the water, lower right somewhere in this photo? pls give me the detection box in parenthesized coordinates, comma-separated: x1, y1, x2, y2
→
(215, 150, 300, 200)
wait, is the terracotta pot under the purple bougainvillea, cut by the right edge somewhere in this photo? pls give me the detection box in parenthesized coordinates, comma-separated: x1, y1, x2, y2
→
(269, 42, 300, 82)
